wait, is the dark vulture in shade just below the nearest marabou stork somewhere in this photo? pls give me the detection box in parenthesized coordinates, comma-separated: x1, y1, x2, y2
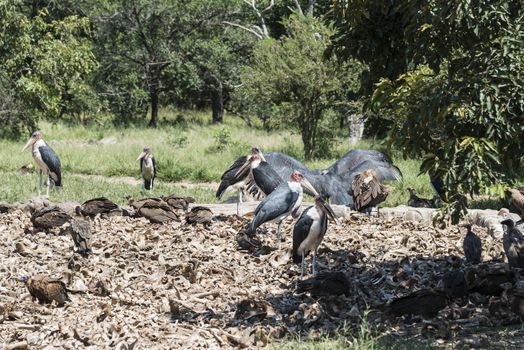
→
(297, 271, 351, 297)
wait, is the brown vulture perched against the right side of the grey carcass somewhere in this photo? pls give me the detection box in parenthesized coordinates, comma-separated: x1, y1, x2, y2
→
(351, 169, 390, 211)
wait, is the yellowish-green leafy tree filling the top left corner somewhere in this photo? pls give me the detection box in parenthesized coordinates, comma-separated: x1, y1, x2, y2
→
(0, 1, 97, 136)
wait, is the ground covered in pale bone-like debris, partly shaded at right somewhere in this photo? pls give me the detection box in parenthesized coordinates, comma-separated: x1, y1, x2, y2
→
(0, 205, 524, 349)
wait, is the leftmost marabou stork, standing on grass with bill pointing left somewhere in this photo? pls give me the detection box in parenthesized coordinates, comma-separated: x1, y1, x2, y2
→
(22, 131, 62, 196)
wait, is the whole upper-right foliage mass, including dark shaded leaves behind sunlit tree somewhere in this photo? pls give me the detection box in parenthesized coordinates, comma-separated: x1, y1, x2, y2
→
(331, 0, 524, 216)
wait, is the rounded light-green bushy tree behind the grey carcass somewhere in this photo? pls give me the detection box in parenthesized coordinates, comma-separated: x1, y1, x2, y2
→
(239, 14, 360, 159)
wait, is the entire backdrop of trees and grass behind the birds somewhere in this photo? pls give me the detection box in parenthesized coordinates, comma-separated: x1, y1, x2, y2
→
(0, 0, 524, 208)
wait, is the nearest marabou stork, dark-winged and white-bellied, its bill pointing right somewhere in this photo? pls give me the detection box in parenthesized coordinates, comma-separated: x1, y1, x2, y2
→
(293, 196, 337, 279)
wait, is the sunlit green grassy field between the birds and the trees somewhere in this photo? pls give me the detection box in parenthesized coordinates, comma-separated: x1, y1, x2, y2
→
(0, 111, 504, 206)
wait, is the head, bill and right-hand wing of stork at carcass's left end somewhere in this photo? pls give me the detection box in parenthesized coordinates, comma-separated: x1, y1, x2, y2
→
(236, 154, 284, 196)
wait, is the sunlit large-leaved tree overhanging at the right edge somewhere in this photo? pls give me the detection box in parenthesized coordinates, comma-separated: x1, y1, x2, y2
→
(373, 0, 524, 219)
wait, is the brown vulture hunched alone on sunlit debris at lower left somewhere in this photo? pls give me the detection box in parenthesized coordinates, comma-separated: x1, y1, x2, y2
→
(20, 274, 71, 306)
